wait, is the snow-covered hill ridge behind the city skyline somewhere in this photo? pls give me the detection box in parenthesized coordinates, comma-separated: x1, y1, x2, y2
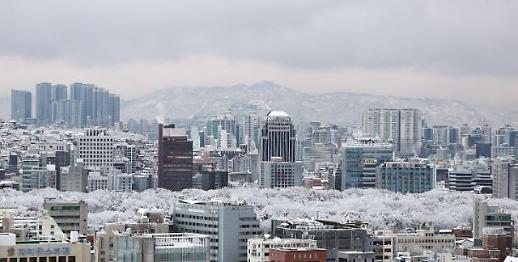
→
(121, 82, 511, 126)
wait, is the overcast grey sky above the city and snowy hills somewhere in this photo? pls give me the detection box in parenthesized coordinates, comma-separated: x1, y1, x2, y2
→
(0, 0, 518, 106)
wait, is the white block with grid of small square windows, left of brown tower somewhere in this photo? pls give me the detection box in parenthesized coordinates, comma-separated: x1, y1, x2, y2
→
(77, 128, 113, 169)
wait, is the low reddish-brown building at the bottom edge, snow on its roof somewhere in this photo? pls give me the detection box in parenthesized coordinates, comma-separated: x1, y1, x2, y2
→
(268, 248, 327, 262)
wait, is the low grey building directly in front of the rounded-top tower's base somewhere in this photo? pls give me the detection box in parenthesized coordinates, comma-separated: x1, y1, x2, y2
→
(259, 157, 303, 188)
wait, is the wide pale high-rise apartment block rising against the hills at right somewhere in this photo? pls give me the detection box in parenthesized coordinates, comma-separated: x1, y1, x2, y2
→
(362, 108, 423, 155)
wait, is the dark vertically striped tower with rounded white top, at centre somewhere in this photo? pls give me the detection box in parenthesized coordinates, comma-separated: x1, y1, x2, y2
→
(261, 111, 296, 162)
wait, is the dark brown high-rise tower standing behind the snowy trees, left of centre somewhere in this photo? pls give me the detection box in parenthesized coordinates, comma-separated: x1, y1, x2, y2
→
(158, 124, 193, 191)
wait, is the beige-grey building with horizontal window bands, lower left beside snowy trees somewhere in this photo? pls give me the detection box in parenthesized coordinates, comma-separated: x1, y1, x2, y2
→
(43, 199, 88, 235)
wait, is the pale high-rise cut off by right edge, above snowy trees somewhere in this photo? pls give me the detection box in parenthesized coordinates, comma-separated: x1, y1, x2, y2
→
(491, 158, 518, 200)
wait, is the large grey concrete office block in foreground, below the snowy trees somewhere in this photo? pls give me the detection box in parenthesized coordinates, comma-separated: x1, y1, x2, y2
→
(174, 199, 262, 262)
